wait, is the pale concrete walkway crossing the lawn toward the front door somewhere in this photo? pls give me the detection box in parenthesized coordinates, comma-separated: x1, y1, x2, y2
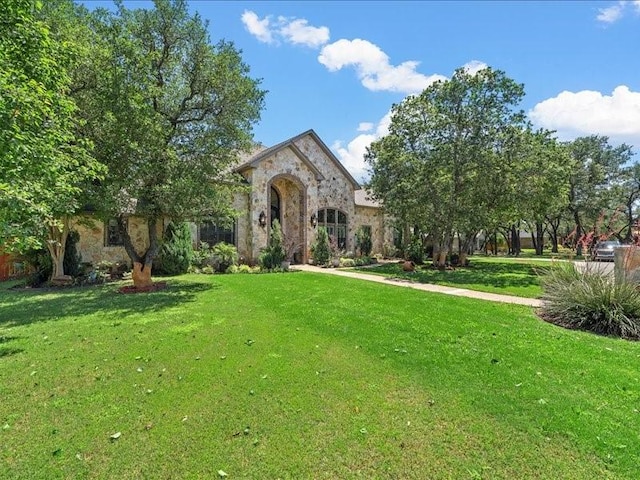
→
(291, 265, 542, 307)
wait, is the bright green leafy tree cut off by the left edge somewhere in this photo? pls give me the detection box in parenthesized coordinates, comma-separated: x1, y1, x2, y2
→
(0, 0, 101, 277)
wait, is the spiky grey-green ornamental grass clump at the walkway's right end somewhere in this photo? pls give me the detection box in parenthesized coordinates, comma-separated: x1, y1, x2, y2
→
(541, 264, 640, 339)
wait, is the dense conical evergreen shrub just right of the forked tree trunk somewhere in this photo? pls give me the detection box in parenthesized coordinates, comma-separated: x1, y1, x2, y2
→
(153, 222, 193, 275)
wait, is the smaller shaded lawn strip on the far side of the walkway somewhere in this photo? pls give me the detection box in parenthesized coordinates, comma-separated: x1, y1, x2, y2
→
(356, 256, 552, 298)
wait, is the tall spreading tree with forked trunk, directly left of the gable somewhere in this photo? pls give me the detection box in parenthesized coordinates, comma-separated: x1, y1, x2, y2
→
(77, 0, 265, 286)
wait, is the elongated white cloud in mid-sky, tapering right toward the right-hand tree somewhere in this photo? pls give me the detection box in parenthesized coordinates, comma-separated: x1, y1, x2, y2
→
(318, 38, 446, 93)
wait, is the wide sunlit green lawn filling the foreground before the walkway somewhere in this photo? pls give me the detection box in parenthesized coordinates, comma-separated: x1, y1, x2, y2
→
(0, 272, 640, 480)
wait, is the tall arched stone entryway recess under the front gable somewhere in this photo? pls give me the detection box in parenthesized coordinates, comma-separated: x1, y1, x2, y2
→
(268, 175, 307, 263)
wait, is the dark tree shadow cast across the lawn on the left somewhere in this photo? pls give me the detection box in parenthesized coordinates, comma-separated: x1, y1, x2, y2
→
(0, 280, 220, 328)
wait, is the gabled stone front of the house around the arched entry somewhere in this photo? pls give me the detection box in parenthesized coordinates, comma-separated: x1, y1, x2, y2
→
(231, 130, 392, 262)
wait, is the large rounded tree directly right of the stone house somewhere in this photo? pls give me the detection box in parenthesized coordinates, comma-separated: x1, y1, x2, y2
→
(366, 68, 525, 266)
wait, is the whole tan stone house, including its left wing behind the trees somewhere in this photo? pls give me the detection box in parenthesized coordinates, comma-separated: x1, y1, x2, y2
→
(74, 130, 393, 263)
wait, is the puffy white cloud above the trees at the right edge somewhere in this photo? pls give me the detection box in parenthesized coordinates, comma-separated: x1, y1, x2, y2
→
(529, 85, 640, 146)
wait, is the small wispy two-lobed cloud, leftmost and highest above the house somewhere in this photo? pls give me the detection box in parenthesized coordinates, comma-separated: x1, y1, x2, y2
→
(241, 10, 329, 48)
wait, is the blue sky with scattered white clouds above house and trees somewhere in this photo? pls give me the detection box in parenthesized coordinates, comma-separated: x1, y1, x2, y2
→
(83, 0, 640, 180)
